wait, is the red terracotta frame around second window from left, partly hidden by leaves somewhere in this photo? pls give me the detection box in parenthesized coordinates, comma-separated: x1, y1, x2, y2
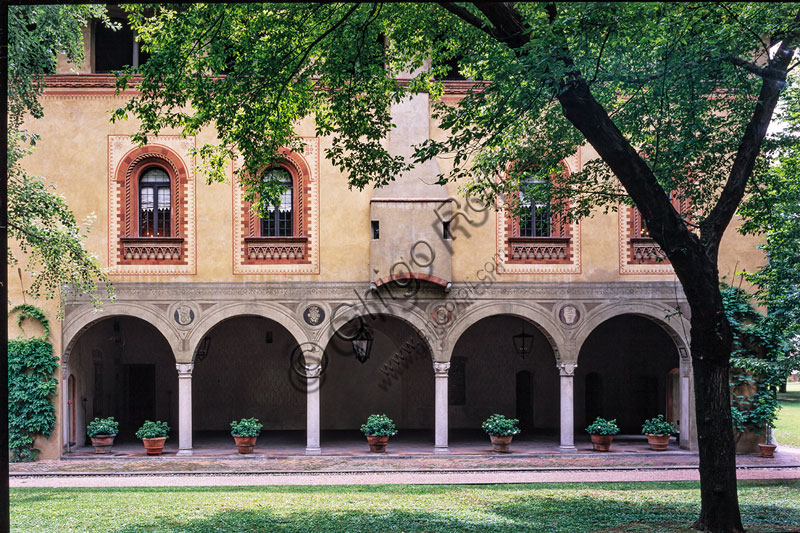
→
(240, 150, 311, 265)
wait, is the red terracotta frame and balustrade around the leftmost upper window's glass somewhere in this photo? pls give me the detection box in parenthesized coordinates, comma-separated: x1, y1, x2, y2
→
(116, 146, 189, 265)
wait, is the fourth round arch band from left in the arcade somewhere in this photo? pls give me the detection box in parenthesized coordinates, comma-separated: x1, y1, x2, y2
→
(442, 302, 566, 364)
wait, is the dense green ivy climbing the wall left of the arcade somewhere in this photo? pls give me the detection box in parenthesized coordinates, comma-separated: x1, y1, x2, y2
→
(8, 304, 58, 462)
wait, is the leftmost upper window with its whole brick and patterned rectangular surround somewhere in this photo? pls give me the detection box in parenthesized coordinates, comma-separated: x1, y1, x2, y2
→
(109, 136, 195, 274)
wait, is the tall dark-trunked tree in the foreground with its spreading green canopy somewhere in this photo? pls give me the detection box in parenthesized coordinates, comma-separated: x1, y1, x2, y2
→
(115, 2, 800, 531)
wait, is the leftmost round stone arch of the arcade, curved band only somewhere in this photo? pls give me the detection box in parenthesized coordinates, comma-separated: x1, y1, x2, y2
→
(61, 303, 182, 363)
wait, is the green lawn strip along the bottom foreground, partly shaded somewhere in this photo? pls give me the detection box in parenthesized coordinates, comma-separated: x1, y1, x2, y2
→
(10, 480, 800, 533)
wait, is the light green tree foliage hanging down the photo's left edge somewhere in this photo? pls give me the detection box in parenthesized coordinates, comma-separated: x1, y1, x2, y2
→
(7, 5, 113, 312)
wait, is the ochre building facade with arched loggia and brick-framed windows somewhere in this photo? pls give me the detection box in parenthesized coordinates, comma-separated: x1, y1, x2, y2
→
(9, 17, 762, 458)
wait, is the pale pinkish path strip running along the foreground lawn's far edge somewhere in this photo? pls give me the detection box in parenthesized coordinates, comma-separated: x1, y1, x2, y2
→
(9, 468, 800, 488)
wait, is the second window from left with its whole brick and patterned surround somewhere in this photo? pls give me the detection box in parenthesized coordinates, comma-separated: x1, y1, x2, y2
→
(233, 138, 319, 274)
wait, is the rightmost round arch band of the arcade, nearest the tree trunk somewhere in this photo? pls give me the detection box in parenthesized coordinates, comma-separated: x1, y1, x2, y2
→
(572, 302, 691, 365)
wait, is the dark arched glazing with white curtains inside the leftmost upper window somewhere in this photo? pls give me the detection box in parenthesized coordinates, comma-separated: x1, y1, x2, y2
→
(139, 167, 172, 237)
